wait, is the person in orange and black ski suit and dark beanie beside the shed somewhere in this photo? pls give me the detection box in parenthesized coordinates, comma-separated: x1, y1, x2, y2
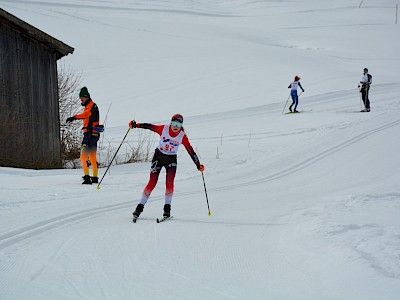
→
(67, 87, 100, 184)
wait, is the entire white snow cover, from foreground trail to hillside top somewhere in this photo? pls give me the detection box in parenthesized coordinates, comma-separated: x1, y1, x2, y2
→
(0, 0, 400, 300)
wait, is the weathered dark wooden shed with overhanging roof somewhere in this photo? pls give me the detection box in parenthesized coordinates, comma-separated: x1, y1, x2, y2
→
(0, 9, 74, 169)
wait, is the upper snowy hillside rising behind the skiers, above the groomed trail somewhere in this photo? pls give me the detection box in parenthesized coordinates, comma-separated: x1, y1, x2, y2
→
(0, 0, 399, 125)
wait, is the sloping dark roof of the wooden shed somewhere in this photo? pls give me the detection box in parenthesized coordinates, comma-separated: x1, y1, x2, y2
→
(0, 8, 74, 59)
